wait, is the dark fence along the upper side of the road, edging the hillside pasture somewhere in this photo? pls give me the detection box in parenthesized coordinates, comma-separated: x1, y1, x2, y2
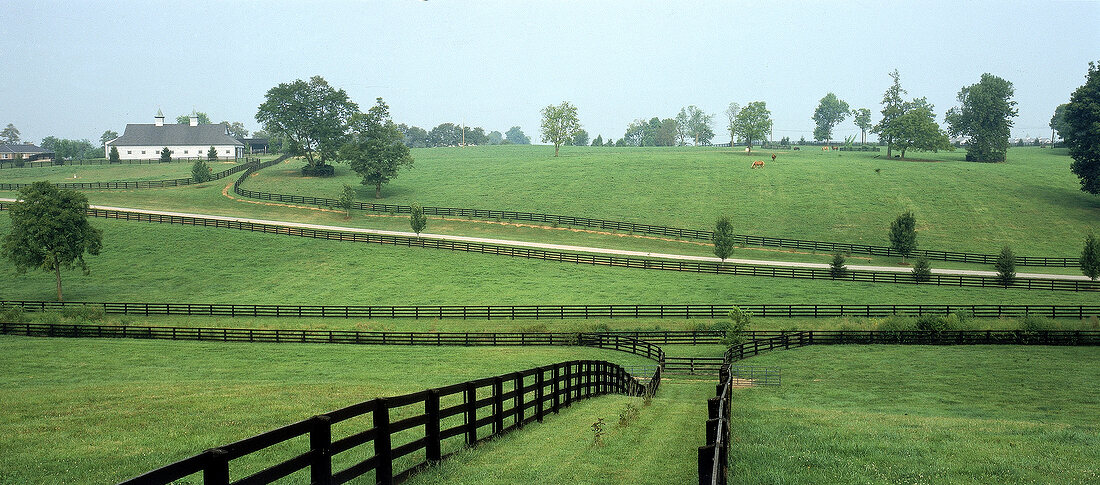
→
(227, 162, 1080, 267)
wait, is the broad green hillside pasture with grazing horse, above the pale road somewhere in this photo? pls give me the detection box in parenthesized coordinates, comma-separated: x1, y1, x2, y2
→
(240, 146, 1100, 256)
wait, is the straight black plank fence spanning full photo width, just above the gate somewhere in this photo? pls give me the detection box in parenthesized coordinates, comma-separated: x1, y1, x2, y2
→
(0, 300, 1100, 318)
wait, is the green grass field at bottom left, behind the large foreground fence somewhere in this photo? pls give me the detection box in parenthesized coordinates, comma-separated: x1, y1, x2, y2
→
(0, 337, 659, 484)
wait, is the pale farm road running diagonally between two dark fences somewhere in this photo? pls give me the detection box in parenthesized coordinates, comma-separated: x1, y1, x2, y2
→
(0, 198, 1089, 282)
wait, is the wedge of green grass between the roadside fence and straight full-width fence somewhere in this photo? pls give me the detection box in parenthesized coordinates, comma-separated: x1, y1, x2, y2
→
(0, 214, 1096, 305)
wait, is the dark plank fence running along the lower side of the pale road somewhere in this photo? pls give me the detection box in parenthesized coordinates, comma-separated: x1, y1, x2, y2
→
(0, 197, 1100, 291)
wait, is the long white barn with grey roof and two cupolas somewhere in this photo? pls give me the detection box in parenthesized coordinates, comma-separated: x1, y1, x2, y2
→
(103, 110, 244, 159)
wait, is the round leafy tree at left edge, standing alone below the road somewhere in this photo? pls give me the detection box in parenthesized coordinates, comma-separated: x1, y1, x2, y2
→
(0, 181, 103, 301)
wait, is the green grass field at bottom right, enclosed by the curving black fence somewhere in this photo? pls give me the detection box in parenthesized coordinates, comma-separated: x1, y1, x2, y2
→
(729, 345, 1100, 484)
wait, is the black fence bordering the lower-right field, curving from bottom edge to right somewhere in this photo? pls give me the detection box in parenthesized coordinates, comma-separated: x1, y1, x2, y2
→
(699, 330, 1100, 485)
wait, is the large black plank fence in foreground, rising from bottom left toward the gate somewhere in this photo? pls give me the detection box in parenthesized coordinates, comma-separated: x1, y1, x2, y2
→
(122, 361, 661, 485)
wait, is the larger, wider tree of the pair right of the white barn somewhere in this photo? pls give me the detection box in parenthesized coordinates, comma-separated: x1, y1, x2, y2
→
(256, 76, 359, 167)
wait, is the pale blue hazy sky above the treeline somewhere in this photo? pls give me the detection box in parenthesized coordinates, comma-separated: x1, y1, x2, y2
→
(0, 0, 1100, 142)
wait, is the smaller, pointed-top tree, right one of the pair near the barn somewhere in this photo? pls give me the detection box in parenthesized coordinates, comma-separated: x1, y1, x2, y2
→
(340, 98, 413, 199)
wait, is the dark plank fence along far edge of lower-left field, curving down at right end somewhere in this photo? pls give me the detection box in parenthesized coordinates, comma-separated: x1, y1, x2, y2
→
(0, 322, 664, 364)
